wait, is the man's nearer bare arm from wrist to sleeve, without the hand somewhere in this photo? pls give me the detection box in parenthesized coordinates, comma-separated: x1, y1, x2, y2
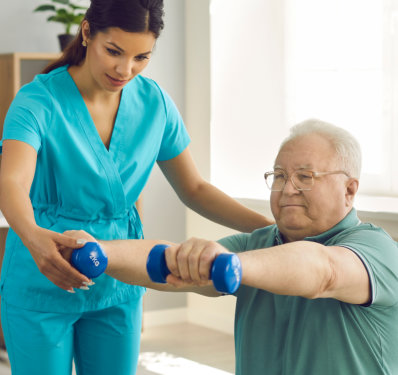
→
(239, 241, 371, 304)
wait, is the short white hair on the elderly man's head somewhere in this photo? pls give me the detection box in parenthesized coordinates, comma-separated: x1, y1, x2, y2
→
(279, 119, 362, 178)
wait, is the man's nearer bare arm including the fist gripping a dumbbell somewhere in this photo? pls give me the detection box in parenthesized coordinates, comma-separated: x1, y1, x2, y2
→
(166, 239, 371, 304)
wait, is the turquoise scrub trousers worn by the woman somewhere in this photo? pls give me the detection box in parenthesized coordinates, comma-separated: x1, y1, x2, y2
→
(1, 298, 142, 375)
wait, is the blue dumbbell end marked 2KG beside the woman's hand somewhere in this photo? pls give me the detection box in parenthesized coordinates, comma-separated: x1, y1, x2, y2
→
(71, 242, 108, 279)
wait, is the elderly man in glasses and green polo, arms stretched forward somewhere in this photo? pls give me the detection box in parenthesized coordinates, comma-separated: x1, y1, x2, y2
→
(66, 120, 398, 375)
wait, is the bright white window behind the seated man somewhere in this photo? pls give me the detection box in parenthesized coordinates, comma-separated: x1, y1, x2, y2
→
(211, 0, 398, 199)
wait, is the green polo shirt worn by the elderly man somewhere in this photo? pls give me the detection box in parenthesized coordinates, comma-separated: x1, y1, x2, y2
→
(220, 210, 398, 375)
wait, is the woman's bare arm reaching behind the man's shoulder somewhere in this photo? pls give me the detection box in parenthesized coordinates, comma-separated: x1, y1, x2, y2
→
(158, 148, 273, 232)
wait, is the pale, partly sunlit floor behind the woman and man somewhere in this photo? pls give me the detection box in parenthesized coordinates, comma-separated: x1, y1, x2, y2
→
(0, 323, 235, 375)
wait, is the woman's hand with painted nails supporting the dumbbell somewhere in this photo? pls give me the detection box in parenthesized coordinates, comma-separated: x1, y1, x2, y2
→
(25, 227, 91, 292)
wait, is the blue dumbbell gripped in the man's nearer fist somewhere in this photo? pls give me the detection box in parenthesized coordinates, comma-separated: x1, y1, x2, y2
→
(146, 245, 242, 294)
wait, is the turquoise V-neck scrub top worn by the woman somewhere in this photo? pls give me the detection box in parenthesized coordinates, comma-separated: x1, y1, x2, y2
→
(0, 66, 190, 313)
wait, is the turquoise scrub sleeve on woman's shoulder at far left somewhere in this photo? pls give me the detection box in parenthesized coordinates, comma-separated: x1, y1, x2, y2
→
(3, 82, 49, 152)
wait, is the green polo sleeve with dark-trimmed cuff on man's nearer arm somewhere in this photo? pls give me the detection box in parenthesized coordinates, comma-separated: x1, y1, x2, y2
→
(336, 225, 398, 306)
